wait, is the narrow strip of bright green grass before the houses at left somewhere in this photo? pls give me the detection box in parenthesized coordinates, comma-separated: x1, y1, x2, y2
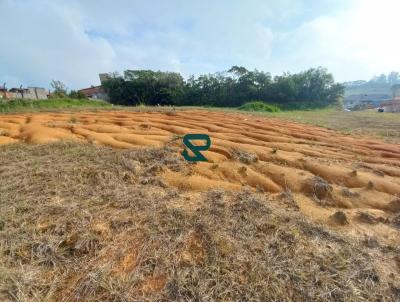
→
(0, 98, 112, 113)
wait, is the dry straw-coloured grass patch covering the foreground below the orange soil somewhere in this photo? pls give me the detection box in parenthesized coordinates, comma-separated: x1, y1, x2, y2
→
(0, 143, 400, 301)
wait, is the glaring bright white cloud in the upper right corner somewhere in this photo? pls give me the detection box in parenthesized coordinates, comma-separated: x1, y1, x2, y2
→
(281, 0, 400, 80)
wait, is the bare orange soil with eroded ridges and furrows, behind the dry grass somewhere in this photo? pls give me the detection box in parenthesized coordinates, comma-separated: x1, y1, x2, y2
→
(0, 110, 400, 239)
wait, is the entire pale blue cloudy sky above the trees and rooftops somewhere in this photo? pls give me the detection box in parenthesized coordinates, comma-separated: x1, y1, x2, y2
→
(0, 0, 400, 88)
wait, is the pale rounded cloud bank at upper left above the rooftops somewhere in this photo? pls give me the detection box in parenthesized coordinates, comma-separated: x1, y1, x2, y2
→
(0, 1, 116, 87)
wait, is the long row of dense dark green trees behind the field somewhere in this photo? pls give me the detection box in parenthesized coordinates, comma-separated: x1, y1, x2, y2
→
(103, 66, 344, 109)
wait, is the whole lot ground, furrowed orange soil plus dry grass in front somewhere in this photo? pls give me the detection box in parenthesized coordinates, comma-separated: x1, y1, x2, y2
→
(0, 111, 400, 301)
